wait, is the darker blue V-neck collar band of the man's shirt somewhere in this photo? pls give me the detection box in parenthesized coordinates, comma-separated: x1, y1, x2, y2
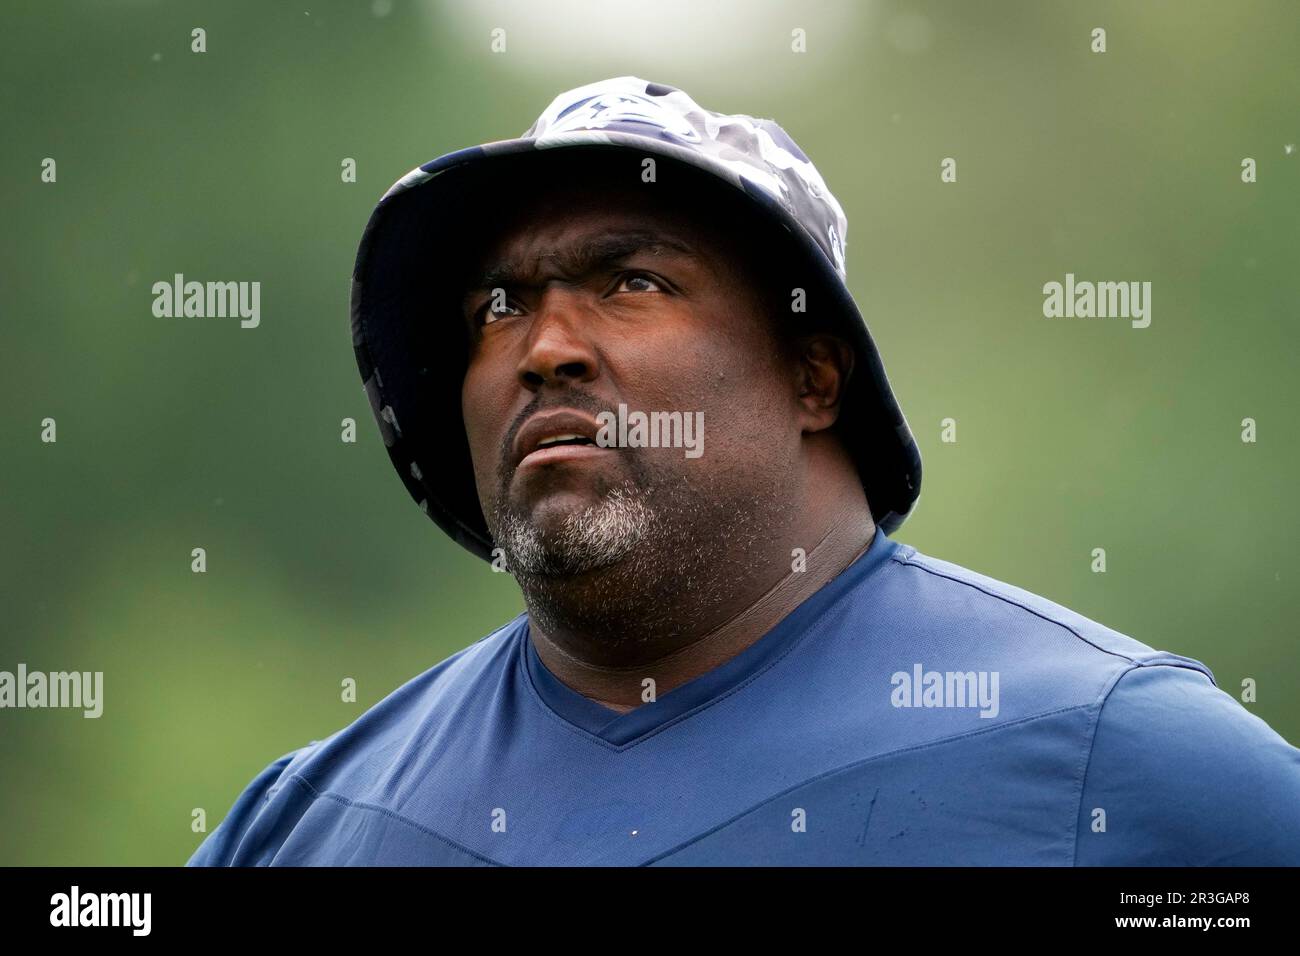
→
(517, 527, 900, 747)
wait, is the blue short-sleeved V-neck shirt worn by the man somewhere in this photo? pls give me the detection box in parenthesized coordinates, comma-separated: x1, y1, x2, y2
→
(190, 531, 1300, 866)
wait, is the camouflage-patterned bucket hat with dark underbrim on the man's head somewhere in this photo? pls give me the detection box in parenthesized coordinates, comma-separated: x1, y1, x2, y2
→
(351, 77, 920, 559)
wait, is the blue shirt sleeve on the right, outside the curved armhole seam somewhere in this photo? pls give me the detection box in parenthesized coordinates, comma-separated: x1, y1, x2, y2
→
(1076, 663, 1300, 866)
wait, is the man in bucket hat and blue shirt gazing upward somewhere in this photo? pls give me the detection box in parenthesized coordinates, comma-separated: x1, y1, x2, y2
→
(190, 77, 1300, 865)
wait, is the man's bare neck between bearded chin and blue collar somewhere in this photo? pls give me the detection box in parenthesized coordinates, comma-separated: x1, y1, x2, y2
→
(520, 460, 875, 711)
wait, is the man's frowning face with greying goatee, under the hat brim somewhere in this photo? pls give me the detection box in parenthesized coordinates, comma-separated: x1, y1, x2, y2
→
(462, 174, 800, 576)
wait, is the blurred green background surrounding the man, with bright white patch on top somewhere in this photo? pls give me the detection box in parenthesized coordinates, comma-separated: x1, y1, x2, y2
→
(0, 0, 1300, 865)
